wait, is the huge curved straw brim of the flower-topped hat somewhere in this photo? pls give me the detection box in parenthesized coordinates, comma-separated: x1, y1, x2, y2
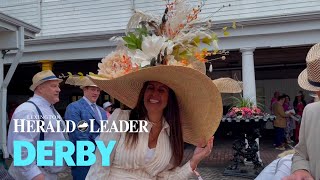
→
(89, 66, 222, 145)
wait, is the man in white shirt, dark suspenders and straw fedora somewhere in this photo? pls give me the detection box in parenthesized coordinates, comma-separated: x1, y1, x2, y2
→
(8, 70, 68, 180)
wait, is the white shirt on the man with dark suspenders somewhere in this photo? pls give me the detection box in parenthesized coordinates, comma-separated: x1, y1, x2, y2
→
(8, 94, 65, 180)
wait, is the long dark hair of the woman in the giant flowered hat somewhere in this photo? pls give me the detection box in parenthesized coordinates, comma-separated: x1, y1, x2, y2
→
(126, 82, 183, 167)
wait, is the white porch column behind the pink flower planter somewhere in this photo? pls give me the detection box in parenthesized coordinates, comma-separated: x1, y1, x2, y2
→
(240, 48, 257, 105)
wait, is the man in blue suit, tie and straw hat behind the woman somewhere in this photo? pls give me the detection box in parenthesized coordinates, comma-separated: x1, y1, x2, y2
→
(65, 76, 107, 180)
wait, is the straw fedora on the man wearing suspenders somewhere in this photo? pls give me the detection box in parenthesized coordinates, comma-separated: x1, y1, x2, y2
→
(30, 70, 62, 91)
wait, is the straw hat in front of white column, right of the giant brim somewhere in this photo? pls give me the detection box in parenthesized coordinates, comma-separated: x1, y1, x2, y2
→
(212, 77, 243, 93)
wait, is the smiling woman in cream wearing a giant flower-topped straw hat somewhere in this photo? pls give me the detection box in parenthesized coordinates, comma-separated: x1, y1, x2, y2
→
(87, 0, 222, 179)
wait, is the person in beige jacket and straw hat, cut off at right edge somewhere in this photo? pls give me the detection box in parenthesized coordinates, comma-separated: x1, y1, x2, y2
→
(285, 43, 320, 180)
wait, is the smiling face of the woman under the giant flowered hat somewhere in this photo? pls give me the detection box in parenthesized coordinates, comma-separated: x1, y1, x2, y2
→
(143, 81, 169, 113)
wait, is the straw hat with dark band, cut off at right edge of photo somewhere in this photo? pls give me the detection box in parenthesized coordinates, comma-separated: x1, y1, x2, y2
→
(298, 43, 320, 91)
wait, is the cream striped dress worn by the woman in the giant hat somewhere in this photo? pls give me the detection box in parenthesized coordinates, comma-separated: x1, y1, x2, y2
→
(86, 109, 193, 180)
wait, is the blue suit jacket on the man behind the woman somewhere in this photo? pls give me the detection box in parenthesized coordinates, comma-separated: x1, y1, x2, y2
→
(65, 98, 107, 144)
